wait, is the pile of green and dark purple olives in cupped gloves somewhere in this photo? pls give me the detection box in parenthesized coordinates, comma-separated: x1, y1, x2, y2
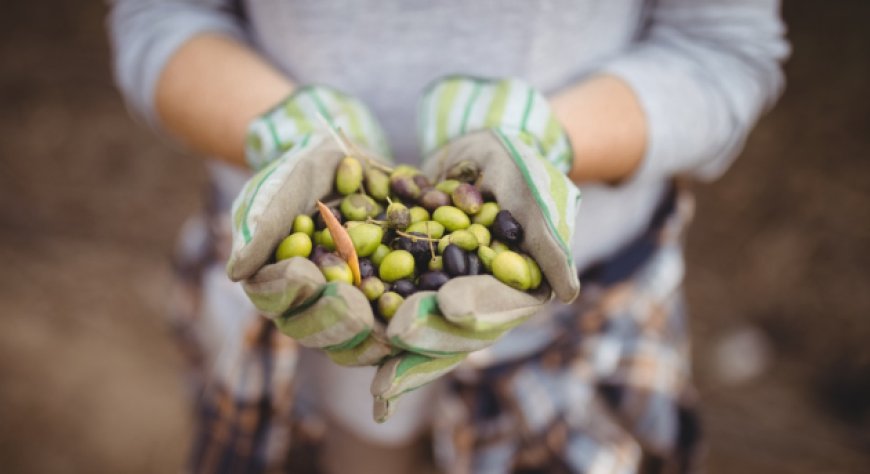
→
(275, 157, 542, 319)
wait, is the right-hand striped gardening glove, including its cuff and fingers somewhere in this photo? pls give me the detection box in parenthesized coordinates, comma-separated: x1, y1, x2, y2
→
(372, 77, 580, 421)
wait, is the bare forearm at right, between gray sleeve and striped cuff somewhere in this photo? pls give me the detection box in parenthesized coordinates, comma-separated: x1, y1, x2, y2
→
(551, 75, 647, 183)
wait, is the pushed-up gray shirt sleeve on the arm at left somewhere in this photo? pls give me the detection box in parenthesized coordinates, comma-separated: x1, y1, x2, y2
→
(108, 0, 244, 128)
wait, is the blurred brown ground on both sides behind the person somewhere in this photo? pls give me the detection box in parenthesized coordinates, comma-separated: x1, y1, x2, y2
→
(0, 0, 870, 473)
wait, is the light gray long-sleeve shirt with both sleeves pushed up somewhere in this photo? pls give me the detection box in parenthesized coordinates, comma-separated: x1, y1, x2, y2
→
(110, 0, 788, 267)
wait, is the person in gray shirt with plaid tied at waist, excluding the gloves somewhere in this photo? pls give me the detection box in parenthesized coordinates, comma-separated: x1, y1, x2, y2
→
(108, 0, 789, 473)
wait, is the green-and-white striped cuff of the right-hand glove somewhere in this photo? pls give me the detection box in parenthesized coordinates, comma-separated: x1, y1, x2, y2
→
(419, 76, 573, 173)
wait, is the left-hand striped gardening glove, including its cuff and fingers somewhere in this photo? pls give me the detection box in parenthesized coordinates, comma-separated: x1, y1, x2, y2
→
(227, 86, 390, 365)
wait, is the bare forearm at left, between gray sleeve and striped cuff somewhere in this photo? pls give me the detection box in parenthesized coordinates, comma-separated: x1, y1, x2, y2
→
(155, 34, 293, 166)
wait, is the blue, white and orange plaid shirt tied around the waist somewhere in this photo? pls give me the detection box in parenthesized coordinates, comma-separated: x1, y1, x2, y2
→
(171, 183, 700, 474)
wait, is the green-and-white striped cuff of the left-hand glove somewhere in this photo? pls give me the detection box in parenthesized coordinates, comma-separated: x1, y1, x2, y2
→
(245, 85, 390, 170)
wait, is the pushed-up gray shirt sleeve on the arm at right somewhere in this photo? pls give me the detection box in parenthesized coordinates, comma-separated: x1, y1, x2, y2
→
(603, 0, 790, 180)
